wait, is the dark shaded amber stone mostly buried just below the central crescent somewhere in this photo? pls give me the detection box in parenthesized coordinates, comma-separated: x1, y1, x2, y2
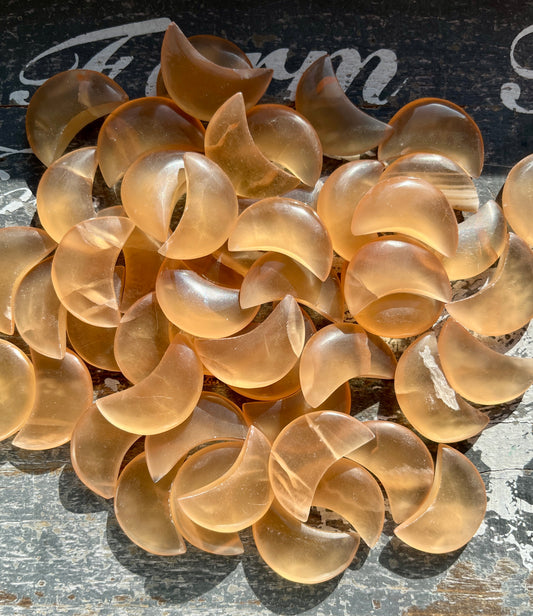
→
(242, 383, 351, 443)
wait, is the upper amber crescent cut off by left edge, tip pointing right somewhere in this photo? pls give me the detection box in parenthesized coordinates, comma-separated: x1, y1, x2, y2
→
(0, 227, 56, 335)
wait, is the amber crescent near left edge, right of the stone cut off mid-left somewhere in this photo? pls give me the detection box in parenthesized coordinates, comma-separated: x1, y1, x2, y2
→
(13, 257, 67, 359)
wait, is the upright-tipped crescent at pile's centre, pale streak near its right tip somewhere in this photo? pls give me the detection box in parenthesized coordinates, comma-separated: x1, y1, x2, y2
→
(195, 295, 305, 388)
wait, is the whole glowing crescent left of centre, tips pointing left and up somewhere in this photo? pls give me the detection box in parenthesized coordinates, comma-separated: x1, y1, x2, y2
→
(96, 334, 203, 434)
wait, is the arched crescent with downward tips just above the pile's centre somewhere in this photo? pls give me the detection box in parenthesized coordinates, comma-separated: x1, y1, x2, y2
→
(228, 197, 333, 281)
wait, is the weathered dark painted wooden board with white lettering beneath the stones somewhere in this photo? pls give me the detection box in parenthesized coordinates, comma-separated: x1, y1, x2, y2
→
(0, 0, 533, 616)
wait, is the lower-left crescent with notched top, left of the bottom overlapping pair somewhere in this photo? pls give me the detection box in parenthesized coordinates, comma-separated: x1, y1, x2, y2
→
(114, 453, 186, 556)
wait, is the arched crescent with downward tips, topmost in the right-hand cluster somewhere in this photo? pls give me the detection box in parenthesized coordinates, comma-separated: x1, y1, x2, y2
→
(352, 176, 458, 257)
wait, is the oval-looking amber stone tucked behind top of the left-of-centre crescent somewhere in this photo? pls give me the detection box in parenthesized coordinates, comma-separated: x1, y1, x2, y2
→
(114, 293, 170, 382)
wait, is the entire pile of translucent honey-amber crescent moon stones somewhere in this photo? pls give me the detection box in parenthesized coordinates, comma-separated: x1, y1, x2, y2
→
(0, 24, 533, 584)
